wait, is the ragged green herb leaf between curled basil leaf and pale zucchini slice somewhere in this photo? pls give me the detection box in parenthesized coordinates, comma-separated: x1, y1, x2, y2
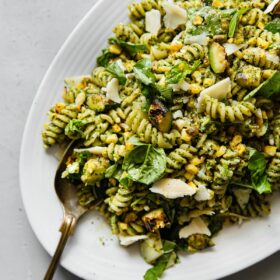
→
(166, 60, 201, 84)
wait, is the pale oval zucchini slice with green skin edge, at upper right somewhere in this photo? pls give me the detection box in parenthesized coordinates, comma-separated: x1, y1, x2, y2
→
(209, 42, 228, 74)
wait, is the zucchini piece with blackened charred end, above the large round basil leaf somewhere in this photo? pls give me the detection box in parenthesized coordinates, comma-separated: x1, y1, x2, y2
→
(149, 100, 172, 133)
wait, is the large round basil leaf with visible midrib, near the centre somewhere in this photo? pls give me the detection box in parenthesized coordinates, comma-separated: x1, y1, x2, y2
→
(122, 144, 166, 185)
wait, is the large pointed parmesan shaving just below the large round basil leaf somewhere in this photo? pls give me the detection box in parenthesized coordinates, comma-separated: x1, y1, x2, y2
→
(150, 178, 197, 199)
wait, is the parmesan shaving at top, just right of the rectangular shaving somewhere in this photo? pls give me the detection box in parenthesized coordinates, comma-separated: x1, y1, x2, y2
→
(162, 1, 187, 29)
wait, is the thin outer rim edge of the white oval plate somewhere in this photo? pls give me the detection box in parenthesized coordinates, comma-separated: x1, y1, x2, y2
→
(18, 0, 280, 278)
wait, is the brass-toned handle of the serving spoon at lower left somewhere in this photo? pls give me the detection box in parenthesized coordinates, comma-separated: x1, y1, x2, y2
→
(44, 215, 77, 280)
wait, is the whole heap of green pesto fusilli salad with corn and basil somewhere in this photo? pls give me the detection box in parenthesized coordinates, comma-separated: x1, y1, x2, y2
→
(42, 0, 280, 280)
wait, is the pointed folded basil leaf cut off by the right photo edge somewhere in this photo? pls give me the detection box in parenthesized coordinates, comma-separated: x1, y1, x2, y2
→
(243, 71, 280, 101)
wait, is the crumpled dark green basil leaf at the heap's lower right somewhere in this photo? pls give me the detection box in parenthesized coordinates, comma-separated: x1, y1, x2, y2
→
(248, 150, 271, 194)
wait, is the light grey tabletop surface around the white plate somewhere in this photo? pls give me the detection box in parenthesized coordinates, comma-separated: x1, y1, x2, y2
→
(0, 0, 280, 280)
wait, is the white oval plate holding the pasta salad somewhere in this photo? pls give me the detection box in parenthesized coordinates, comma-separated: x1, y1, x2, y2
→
(20, 0, 280, 280)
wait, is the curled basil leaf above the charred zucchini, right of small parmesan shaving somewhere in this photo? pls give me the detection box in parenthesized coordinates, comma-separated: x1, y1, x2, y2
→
(133, 58, 156, 86)
